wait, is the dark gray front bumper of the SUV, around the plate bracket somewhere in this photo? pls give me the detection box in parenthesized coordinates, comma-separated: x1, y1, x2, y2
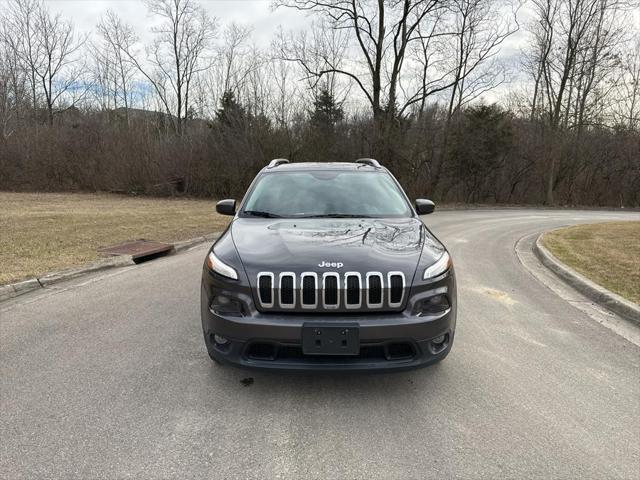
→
(201, 269, 456, 372)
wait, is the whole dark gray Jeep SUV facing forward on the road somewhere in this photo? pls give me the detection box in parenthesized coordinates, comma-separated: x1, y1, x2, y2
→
(201, 159, 456, 371)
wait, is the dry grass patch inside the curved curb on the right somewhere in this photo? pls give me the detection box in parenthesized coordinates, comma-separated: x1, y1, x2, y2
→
(543, 222, 640, 304)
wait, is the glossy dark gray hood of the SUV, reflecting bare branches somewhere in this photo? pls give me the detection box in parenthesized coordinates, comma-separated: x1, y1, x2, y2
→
(231, 218, 442, 284)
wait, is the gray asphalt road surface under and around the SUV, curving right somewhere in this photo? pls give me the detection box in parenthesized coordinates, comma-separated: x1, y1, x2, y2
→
(0, 210, 640, 479)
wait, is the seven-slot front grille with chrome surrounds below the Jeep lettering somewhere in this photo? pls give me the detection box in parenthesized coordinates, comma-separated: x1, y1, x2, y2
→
(257, 272, 406, 310)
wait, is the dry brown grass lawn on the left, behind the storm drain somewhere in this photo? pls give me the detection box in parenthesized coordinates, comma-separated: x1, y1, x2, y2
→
(0, 192, 231, 285)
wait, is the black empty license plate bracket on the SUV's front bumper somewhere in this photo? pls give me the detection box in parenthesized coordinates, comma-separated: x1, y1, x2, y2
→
(302, 322, 360, 355)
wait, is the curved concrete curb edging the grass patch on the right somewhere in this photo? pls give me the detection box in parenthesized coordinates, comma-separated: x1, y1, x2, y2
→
(533, 233, 640, 326)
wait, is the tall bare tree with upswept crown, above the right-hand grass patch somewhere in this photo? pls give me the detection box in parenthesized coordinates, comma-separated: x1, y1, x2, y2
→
(529, 0, 632, 204)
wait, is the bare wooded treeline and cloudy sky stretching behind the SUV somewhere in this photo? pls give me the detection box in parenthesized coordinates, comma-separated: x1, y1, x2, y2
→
(0, 0, 640, 207)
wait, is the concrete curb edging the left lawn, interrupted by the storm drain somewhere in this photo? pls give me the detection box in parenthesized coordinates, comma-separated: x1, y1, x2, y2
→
(0, 232, 221, 302)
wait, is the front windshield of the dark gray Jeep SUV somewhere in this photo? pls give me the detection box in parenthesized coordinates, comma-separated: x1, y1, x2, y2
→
(242, 170, 411, 217)
